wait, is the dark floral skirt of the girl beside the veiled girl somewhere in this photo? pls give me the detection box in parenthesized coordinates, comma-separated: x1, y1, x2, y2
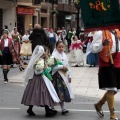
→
(52, 72, 71, 102)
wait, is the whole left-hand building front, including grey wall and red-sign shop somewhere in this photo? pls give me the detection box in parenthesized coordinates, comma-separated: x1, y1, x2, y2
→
(0, 0, 57, 34)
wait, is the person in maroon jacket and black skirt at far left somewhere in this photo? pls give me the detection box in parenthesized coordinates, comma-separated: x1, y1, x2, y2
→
(0, 29, 17, 84)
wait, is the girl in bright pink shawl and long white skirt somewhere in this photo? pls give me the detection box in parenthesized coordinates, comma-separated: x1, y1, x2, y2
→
(69, 36, 84, 66)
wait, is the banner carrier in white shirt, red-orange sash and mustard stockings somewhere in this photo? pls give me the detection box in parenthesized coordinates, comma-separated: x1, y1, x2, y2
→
(91, 30, 120, 120)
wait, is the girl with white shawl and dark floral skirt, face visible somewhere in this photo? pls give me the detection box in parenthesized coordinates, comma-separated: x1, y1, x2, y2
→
(52, 41, 74, 115)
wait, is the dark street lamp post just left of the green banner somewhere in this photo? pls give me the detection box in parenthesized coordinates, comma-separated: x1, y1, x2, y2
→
(74, 0, 80, 38)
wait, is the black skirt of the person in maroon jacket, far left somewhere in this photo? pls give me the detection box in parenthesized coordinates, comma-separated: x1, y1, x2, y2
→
(0, 53, 12, 65)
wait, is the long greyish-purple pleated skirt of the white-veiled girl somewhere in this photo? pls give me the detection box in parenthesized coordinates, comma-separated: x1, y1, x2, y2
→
(21, 75, 54, 106)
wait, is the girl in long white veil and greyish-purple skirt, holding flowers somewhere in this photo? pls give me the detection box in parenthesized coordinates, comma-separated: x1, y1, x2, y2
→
(21, 45, 60, 117)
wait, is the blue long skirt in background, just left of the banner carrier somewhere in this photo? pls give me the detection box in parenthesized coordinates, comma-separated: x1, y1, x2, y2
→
(87, 53, 98, 65)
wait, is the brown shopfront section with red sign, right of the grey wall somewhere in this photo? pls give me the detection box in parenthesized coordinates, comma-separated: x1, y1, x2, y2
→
(16, 0, 57, 33)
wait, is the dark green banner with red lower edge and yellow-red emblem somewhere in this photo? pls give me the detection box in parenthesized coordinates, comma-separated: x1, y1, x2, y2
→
(80, 0, 120, 31)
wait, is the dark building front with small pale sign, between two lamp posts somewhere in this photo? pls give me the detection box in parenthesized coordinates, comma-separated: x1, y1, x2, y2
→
(57, 0, 77, 30)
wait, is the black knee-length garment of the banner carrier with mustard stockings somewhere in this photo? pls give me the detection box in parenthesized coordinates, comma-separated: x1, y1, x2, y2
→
(98, 66, 120, 91)
